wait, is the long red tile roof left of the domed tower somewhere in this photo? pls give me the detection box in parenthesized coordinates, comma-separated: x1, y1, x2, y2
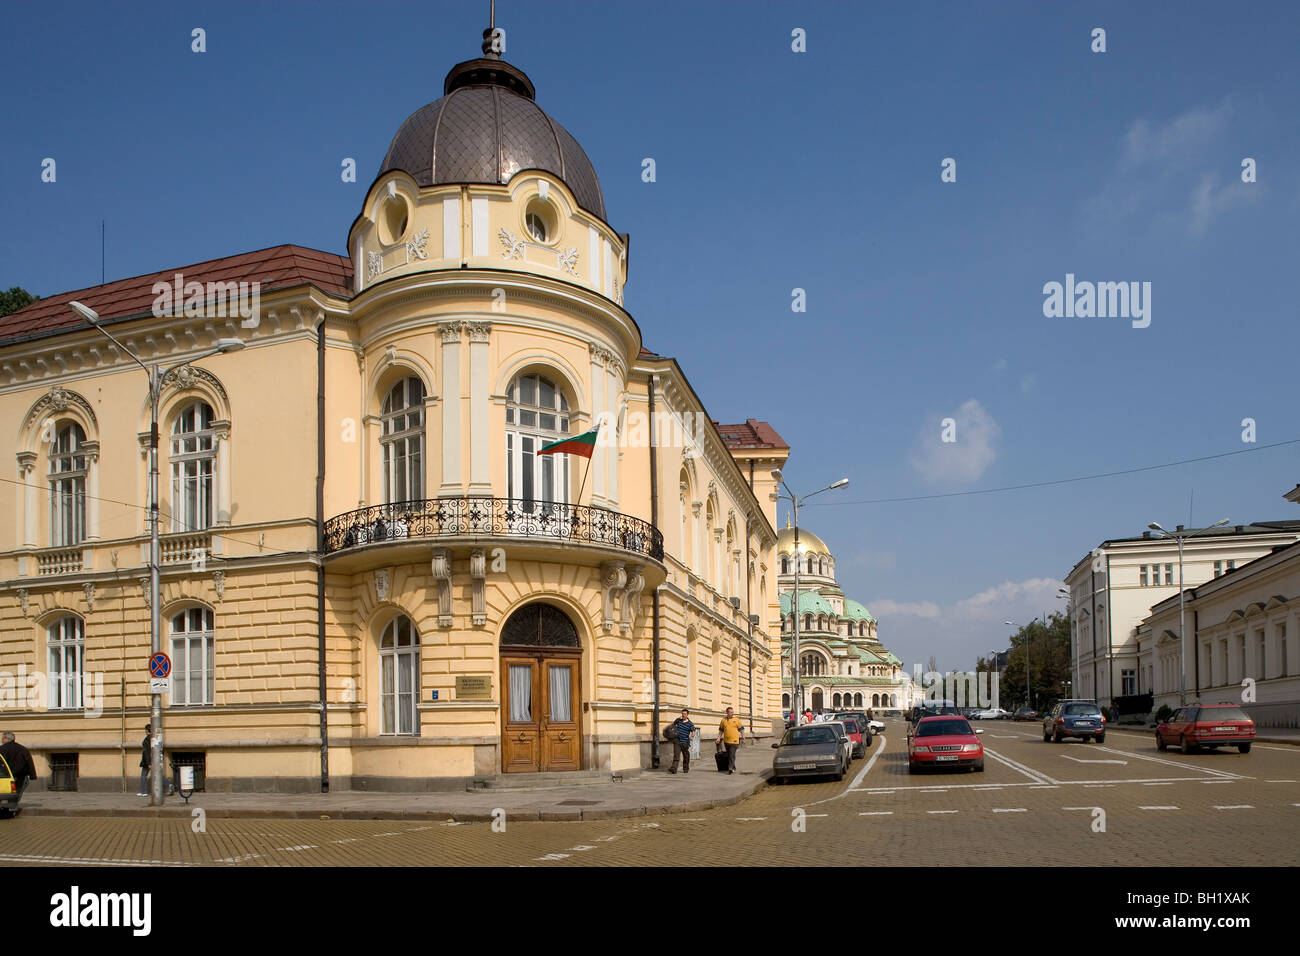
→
(0, 246, 352, 343)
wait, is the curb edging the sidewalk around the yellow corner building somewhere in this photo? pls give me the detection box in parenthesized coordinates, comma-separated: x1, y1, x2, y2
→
(22, 767, 772, 823)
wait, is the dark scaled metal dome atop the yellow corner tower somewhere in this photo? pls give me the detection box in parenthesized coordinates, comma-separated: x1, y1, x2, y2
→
(380, 55, 605, 220)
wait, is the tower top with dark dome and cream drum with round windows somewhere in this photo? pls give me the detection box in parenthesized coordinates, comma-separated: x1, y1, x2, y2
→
(348, 30, 628, 306)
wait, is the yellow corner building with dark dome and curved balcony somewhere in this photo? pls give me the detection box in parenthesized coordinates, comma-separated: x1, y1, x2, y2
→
(0, 37, 789, 791)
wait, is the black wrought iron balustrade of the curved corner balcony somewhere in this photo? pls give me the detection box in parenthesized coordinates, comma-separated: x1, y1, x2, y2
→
(321, 497, 663, 561)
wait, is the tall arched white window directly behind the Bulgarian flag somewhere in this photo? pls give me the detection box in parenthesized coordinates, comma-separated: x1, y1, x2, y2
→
(506, 375, 569, 514)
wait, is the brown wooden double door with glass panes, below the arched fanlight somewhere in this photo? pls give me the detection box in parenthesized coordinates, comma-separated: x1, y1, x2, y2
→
(501, 646, 582, 774)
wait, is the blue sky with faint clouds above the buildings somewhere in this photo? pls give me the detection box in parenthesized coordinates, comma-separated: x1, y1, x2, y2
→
(0, 0, 1300, 667)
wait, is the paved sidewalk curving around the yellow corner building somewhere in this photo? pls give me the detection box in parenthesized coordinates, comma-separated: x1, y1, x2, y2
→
(22, 739, 772, 821)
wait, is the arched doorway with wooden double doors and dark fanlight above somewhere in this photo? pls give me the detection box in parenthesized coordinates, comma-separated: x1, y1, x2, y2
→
(501, 604, 582, 774)
